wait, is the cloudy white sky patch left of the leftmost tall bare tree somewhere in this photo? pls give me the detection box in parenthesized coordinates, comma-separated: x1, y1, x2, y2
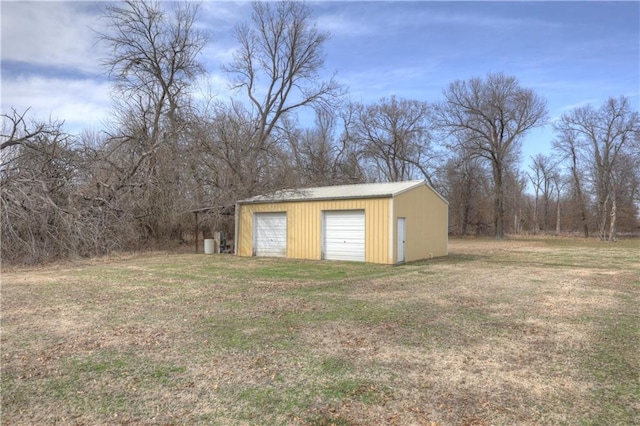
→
(1, 2, 110, 132)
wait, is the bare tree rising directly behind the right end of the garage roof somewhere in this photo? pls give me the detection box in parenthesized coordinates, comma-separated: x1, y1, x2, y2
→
(351, 96, 436, 185)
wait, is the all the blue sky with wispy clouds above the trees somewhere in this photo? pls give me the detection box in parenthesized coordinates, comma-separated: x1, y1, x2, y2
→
(0, 1, 640, 163)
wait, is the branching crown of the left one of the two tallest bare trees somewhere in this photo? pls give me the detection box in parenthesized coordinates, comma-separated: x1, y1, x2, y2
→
(99, 0, 208, 123)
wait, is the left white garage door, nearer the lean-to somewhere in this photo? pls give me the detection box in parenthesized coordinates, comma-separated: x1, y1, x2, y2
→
(253, 213, 287, 257)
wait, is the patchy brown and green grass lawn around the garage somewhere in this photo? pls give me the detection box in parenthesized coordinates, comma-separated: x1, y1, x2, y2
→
(0, 238, 640, 426)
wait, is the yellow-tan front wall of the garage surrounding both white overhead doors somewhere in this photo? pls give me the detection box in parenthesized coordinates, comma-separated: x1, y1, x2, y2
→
(237, 198, 393, 263)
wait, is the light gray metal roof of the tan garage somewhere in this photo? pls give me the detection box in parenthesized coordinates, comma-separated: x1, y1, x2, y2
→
(238, 180, 435, 204)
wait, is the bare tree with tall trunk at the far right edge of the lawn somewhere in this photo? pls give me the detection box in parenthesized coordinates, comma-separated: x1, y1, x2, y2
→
(555, 97, 640, 241)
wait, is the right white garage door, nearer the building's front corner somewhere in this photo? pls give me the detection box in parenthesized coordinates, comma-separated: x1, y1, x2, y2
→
(322, 210, 364, 262)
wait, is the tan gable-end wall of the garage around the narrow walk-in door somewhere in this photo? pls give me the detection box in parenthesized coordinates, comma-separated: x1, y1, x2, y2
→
(393, 185, 449, 262)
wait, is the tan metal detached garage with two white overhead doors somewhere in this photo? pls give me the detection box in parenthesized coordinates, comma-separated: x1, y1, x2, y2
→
(235, 181, 448, 264)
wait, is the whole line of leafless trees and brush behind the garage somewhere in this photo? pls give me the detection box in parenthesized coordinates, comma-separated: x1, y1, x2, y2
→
(0, 1, 640, 263)
